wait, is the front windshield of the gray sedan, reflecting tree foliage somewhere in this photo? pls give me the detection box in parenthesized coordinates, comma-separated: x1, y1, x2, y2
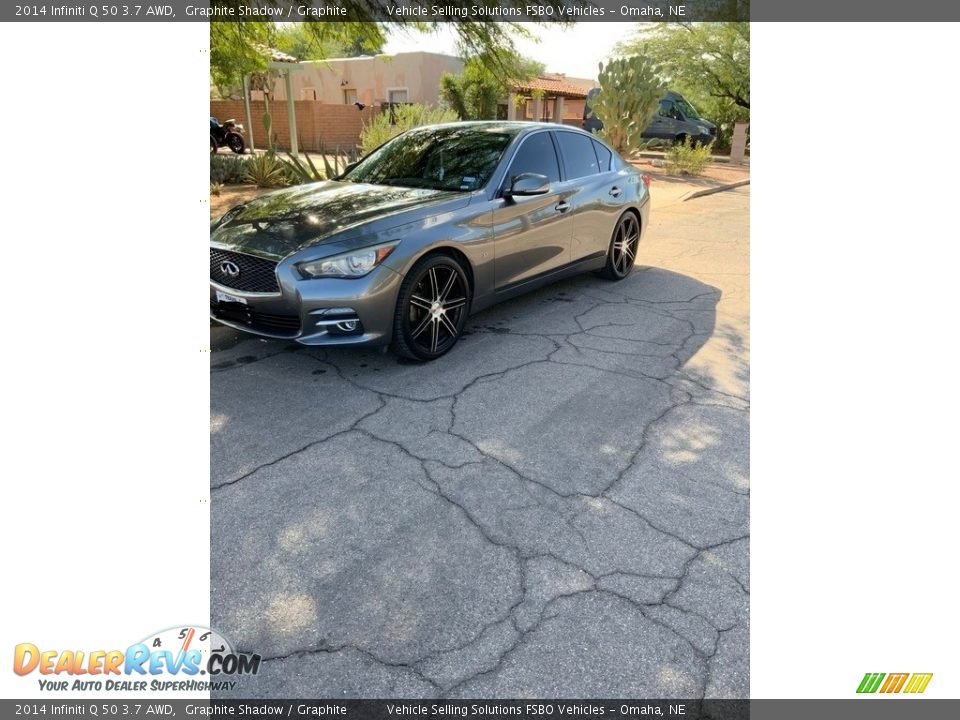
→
(340, 125, 513, 192)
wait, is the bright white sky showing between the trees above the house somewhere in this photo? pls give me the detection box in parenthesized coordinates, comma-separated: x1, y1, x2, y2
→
(384, 22, 637, 78)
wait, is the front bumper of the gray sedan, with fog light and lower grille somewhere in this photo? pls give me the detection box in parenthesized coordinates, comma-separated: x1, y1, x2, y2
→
(210, 265, 402, 346)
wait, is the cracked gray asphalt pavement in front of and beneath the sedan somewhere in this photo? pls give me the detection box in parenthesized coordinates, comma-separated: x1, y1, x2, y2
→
(210, 187, 750, 699)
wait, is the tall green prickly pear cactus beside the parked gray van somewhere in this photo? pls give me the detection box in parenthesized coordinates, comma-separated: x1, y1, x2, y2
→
(590, 55, 663, 155)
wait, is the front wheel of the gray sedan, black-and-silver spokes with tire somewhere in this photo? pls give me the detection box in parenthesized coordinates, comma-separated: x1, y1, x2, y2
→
(391, 255, 471, 362)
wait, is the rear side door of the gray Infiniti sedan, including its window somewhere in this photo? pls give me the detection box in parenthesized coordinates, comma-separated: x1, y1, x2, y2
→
(554, 130, 623, 262)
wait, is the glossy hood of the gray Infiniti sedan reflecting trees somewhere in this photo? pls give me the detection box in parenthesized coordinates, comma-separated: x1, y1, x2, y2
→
(210, 180, 469, 260)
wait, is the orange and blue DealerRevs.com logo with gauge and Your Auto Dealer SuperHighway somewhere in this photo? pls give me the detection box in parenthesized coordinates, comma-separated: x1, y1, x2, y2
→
(13, 625, 261, 692)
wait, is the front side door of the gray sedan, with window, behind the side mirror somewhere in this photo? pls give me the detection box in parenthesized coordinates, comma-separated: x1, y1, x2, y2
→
(493, 130, 573, 290)
